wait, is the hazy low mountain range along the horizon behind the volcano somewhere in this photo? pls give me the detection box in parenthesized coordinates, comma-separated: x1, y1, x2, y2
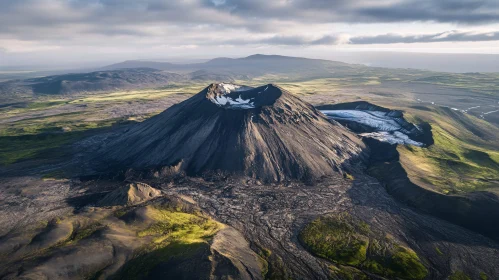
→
(0, 54, 497, 98)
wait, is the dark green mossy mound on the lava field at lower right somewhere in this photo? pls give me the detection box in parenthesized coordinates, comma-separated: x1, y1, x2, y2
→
(299, 214, 428, 279)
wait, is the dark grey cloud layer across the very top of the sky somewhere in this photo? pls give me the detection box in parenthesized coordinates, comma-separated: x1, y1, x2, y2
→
(0, 0, 499, 36)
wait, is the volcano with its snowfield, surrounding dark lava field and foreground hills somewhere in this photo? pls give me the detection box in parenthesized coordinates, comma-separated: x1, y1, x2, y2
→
(0, 83, 499, 279)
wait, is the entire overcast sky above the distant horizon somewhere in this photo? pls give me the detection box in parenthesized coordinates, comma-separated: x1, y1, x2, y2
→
(0, 0, 499, 66)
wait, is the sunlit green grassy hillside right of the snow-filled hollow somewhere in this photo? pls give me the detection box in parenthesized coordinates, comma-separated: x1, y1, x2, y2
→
(397, 109, 499, 194)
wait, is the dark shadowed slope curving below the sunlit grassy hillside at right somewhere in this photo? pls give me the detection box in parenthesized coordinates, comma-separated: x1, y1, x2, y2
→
(366, 139, 499, 240)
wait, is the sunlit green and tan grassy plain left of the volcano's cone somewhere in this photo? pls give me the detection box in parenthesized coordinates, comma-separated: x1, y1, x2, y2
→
(0, 84, 205, 166)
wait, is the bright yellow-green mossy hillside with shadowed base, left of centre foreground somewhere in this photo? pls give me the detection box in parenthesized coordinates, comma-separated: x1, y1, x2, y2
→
(115, 205, 222, 279)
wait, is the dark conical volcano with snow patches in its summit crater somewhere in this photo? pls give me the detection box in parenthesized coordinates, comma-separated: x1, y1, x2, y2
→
(98, 84, 364, 181)
